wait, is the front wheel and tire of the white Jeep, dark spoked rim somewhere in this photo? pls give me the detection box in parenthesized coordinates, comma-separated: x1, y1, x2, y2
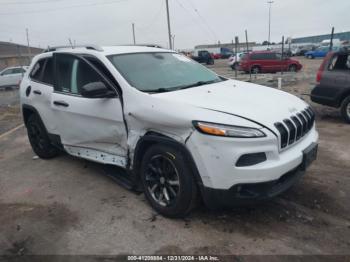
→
(140, 144, 198, 218)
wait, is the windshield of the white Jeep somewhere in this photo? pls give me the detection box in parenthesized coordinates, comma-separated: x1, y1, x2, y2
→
(108, 52, 223, 92)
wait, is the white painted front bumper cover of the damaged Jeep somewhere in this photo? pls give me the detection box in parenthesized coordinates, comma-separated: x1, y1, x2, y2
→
(186, 125, 318, 190)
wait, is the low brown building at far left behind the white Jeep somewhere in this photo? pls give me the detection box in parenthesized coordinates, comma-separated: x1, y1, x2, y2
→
(0, 41, 43, 70)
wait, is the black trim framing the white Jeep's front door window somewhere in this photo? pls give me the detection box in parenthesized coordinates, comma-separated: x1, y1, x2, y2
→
(52, 52, 123, 98)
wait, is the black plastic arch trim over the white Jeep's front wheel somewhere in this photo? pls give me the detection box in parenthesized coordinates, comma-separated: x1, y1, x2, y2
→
(131, 132, 203, 188)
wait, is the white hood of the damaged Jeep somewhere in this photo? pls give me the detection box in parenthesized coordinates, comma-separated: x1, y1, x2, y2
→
(155, 80, 308, 130)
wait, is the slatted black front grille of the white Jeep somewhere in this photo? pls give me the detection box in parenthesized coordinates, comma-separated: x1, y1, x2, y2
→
(275, 107, 315, 149)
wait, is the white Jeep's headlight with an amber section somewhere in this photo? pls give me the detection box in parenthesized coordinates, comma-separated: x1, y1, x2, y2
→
(193, 121, 266, 138)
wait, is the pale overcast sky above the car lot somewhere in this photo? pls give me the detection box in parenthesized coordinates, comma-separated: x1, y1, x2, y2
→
(0, 0, 350, 49)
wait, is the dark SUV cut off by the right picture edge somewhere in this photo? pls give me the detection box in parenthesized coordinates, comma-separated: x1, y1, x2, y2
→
(311, 50, 350, 123)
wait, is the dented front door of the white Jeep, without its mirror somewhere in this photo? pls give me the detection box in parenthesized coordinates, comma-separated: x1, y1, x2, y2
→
(51, 53, 127, 166)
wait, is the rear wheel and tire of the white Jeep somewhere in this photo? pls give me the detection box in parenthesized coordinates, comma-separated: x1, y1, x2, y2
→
(27, 114, 59, 159)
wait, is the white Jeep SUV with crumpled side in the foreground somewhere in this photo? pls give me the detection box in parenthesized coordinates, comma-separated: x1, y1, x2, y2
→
(20, 46, 318, 217)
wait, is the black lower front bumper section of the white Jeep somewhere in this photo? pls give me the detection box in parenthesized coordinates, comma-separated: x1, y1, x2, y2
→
(201, 166, 305, 209)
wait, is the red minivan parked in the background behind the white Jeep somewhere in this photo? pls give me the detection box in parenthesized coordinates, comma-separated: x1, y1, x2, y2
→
(240, 51, 303, 74)
